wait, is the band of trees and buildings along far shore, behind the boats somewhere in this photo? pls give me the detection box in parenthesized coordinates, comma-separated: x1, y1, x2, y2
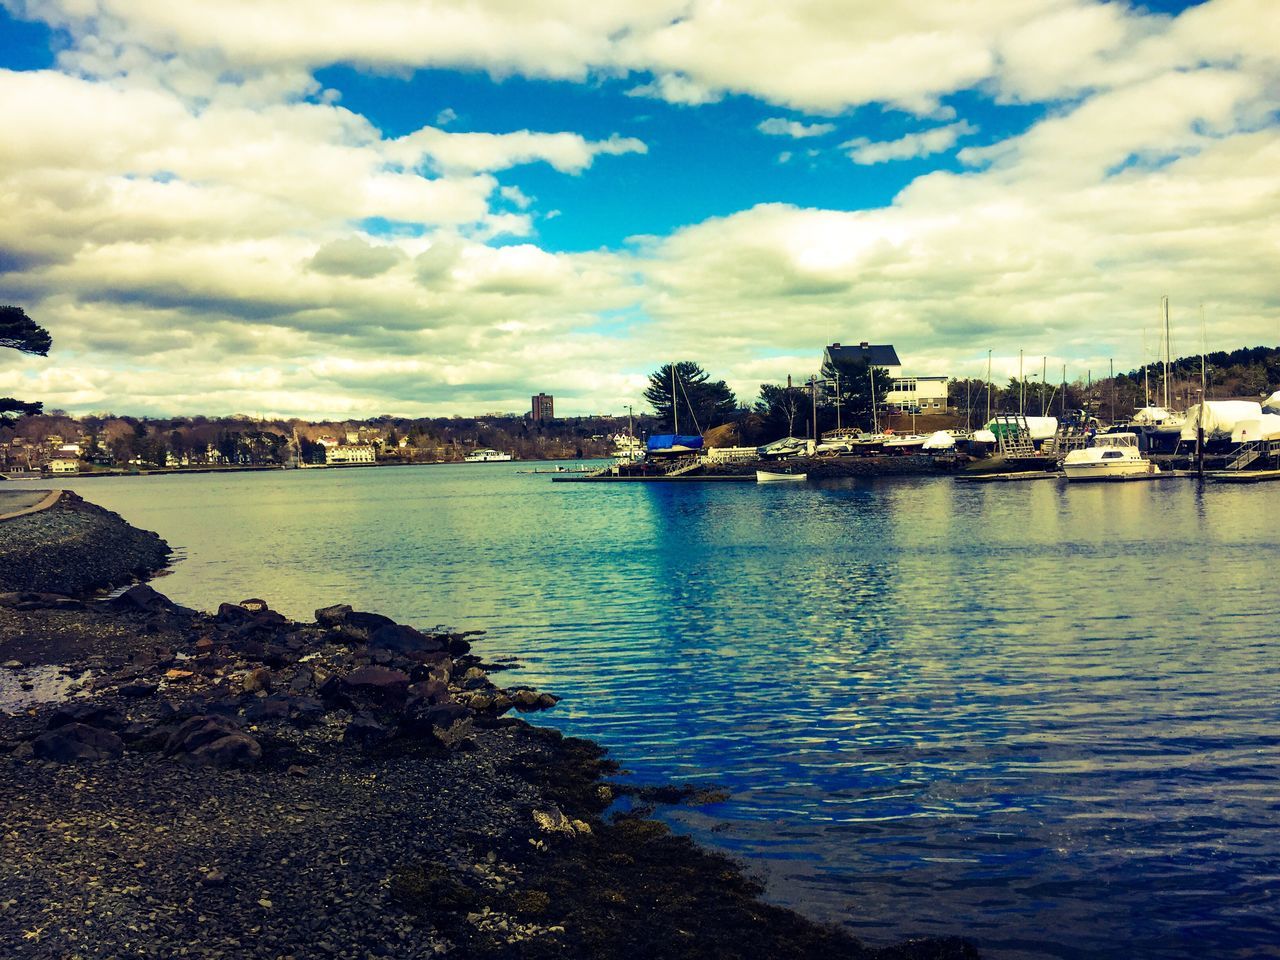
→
(0, 342, 1280, 476)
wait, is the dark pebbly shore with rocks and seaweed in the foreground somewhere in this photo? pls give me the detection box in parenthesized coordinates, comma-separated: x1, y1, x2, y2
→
(0, 495, 978, 960)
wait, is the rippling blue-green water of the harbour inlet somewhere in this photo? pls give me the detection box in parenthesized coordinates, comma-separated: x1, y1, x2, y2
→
(37, 463, 1280, 960)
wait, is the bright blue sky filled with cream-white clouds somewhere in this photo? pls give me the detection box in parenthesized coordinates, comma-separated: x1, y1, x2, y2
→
(0, 0, 1280, 419)
